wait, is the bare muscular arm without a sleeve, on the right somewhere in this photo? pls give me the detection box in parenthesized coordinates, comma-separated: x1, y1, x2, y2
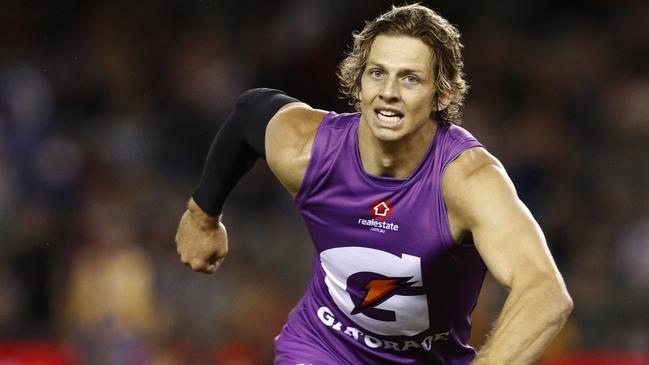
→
(443, 148, 572, 365)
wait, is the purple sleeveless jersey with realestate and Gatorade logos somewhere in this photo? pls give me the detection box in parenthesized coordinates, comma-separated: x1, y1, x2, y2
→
(275, 113, 486, 365)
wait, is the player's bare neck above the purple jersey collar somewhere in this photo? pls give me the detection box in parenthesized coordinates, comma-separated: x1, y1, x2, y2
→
(358, 118, 437, 179)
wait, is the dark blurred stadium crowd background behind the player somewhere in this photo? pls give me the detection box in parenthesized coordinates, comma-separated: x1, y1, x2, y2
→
(0, 0, 649, 365)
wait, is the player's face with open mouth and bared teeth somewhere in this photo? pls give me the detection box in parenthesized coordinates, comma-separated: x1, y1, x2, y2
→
(359, 35, 435, 142)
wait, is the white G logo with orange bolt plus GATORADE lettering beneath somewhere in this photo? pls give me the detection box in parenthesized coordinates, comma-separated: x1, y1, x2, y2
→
(315, 246, 451, 352)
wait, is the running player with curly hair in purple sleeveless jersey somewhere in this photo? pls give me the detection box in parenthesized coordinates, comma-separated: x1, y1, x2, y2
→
(176, 5, 572, 365)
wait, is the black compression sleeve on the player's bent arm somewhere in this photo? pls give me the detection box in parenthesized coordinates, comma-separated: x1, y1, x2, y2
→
(192, 89, 299, 215)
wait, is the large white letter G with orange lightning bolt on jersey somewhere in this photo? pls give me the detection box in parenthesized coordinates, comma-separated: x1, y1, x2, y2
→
(320, 246, 429, 336)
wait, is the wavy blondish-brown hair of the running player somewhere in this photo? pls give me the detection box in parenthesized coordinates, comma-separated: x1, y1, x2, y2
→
(337, 4, 469, 124)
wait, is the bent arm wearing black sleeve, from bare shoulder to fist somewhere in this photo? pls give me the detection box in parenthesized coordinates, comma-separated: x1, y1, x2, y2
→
(175, 89, 324, 273)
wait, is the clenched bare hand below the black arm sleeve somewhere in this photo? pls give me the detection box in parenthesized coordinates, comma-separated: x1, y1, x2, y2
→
(176, 200, 228, 274)
